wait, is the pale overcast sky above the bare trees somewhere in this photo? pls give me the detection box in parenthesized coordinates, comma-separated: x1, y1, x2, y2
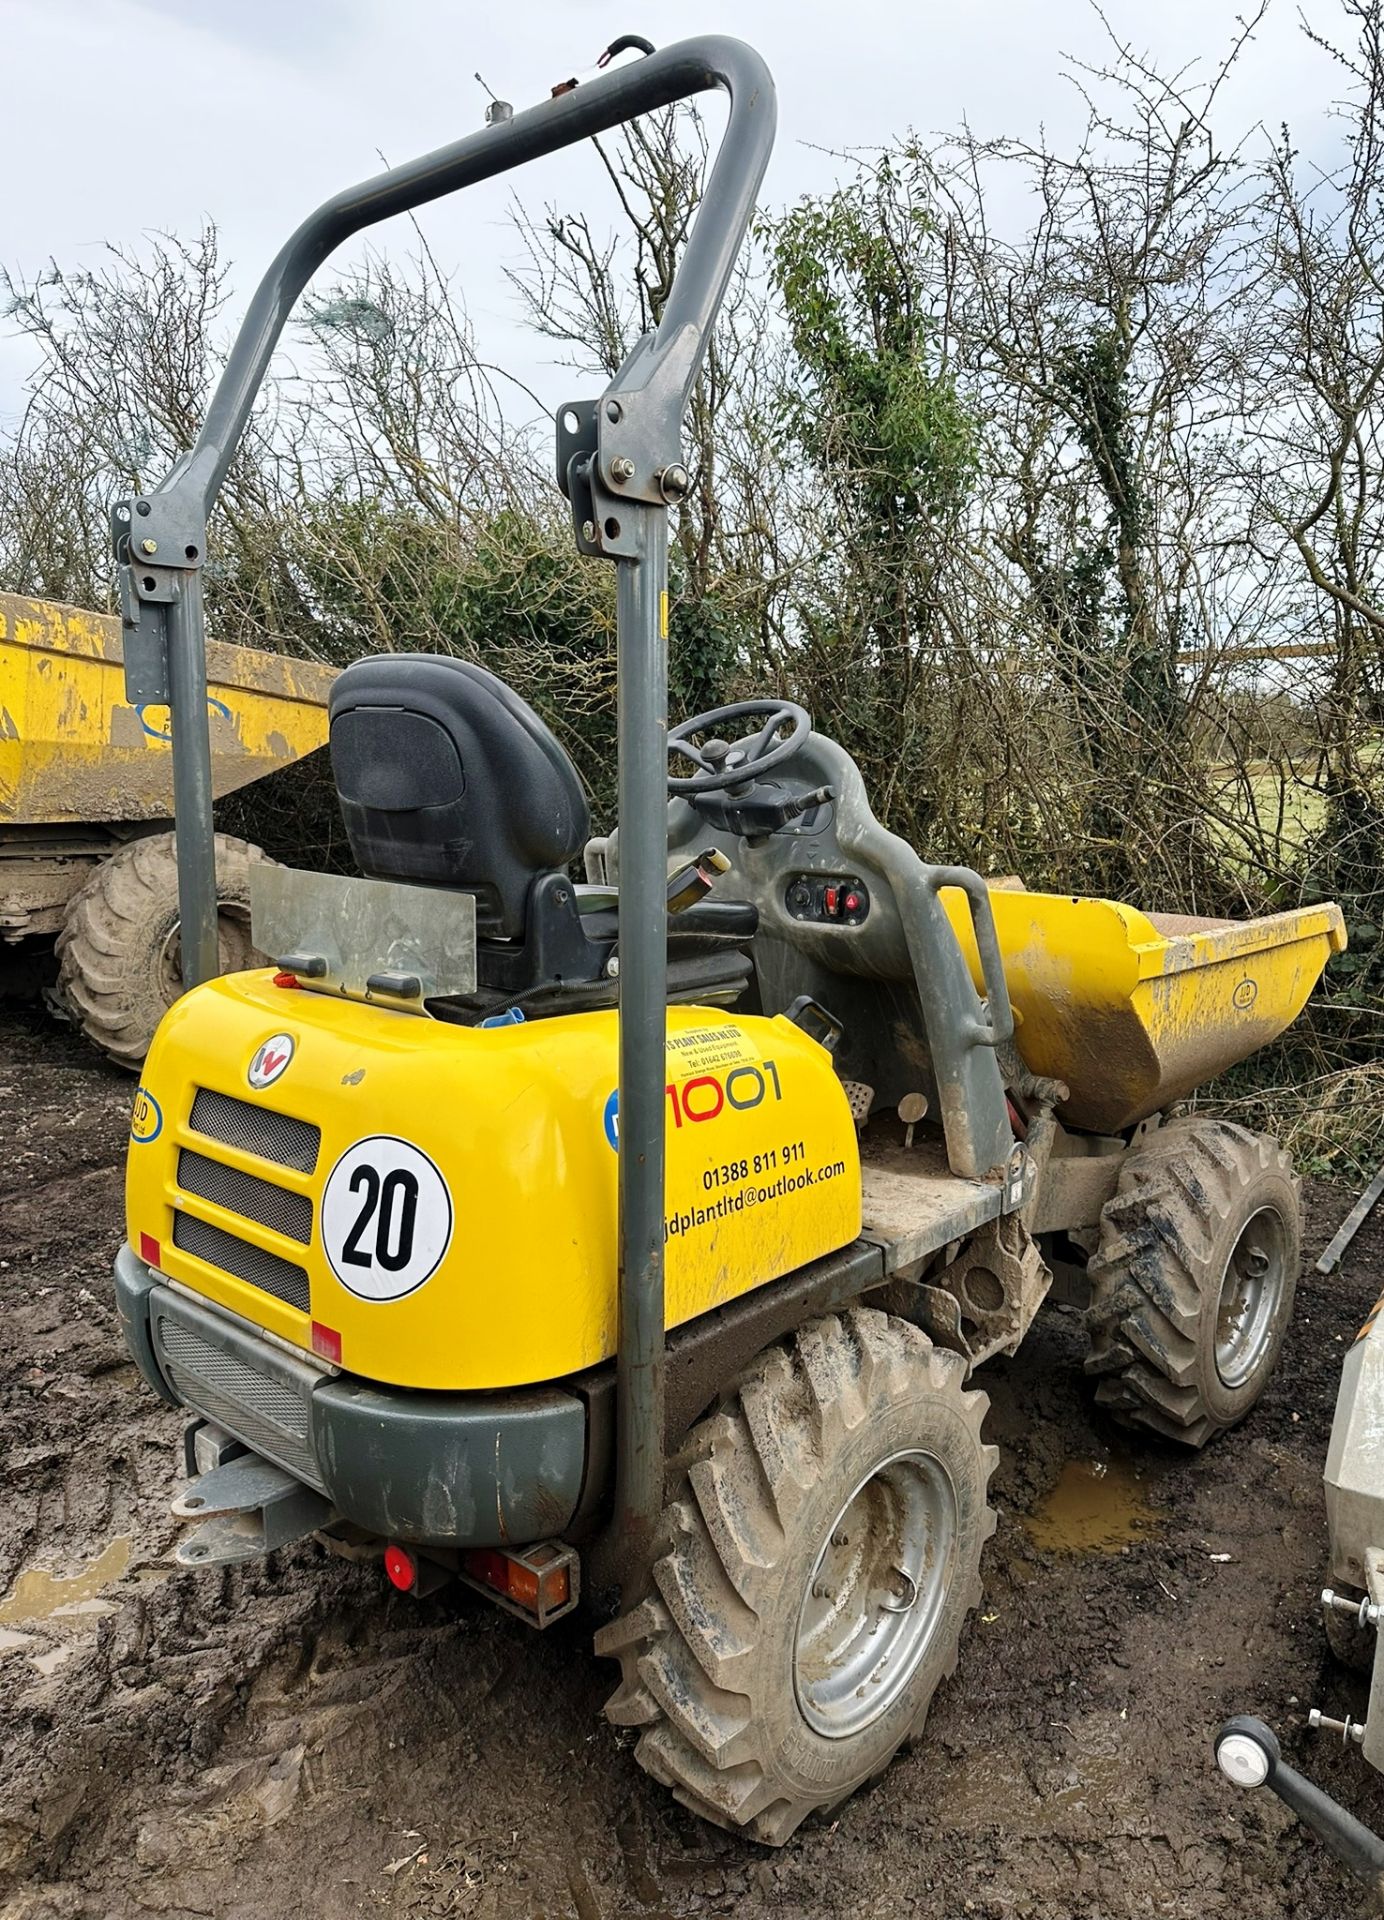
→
(0, 0, 1338, 437)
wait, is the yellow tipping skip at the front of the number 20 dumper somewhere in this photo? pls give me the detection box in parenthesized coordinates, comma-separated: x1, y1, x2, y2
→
(943, 887, 1346, 1133)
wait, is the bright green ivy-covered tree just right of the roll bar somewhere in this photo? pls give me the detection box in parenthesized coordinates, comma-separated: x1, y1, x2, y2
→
(762, 154, 981, 839)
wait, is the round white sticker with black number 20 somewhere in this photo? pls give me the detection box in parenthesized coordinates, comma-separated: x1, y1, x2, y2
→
(322, 1133, 451, 1300)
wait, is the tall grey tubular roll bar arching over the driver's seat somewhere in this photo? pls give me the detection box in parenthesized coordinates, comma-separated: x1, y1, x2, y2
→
(111, 36, 776, 1567)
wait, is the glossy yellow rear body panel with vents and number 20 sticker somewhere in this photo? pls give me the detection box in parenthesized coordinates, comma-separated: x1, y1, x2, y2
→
(127, 973, 860, 1388)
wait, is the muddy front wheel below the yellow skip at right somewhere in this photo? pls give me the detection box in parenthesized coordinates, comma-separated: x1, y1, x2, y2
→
(1086, 1119, 1301, 1448)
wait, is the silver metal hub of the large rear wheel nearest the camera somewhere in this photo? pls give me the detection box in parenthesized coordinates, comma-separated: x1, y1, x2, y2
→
(793, 1453, 958, 1740)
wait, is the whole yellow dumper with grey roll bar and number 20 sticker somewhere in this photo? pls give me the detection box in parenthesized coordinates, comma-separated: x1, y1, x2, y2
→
(111, 35, 1340, 1847)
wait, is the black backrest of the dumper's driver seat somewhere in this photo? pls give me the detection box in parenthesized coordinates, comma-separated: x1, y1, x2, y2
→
(328, 653, 591, 939)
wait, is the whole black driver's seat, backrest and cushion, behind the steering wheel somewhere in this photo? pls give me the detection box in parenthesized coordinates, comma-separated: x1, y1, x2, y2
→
(328, 653, 758, 1016)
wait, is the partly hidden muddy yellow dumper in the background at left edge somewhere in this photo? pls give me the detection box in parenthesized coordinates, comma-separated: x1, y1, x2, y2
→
(0, 593, 336, 1068)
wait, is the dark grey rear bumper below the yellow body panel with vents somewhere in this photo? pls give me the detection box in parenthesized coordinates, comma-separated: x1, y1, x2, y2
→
(115, 1246, 587, 1548)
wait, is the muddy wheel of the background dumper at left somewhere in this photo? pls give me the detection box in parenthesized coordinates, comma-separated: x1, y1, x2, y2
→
(56, 833, 267, 1073)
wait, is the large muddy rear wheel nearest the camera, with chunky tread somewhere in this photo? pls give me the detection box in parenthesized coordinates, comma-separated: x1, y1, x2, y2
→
(597, 1308, 998, 1847)
